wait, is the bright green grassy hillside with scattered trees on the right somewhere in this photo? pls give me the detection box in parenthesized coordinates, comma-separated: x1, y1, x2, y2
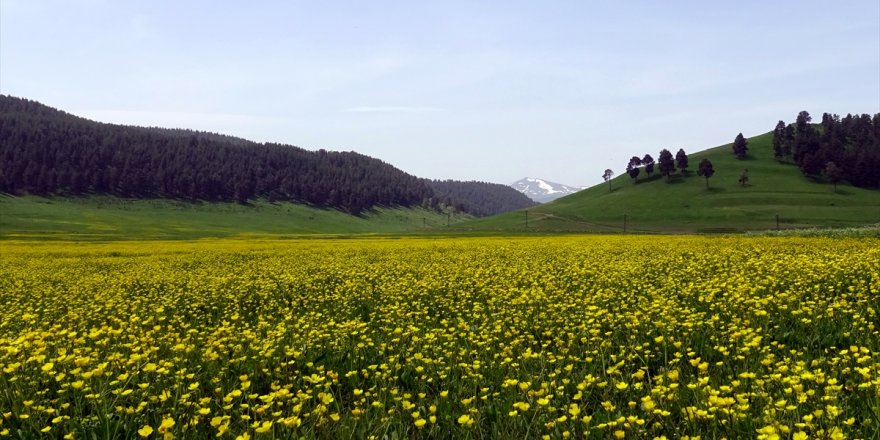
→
(455, 133, 880, 232)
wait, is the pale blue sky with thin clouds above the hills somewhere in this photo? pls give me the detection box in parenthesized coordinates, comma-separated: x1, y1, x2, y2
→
(0, 0, 880, 186)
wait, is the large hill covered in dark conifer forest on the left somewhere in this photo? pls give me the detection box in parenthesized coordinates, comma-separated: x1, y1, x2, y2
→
(0, 95, 528, 214)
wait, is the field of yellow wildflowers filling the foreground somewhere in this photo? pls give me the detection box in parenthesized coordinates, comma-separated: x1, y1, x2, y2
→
(0, 236, 880, 439)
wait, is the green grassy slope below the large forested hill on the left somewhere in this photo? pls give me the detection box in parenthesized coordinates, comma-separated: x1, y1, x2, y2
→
(0, 196, 468, 240)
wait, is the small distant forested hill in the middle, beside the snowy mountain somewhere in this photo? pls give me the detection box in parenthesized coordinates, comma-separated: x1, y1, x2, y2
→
(427, 180, 537, 217)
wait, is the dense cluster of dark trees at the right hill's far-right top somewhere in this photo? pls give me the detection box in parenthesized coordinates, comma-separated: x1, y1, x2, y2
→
(773, 111, 880, 188)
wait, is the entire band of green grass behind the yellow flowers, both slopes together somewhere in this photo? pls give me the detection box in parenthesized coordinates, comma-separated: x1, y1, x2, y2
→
(0, 133, 880, 240)
